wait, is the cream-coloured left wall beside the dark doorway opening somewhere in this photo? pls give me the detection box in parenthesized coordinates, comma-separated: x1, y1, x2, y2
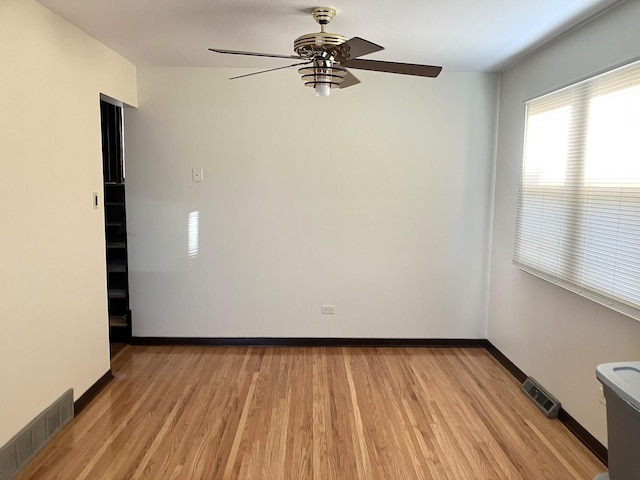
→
(0, 0, 136, 445)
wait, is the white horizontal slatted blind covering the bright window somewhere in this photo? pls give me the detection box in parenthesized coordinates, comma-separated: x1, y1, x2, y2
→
(514, 62, 640, 320)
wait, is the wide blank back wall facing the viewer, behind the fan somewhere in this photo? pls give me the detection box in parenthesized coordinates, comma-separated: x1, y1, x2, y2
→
(125, 68, 498, 338)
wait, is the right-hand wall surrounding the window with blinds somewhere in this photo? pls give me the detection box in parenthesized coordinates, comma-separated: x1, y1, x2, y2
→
(488, 0, 640, 443)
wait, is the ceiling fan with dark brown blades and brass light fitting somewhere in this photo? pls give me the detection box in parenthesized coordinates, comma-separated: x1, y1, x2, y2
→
(209, 7, 442, 97)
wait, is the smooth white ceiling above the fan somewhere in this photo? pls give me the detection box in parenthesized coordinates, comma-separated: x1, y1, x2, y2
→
(39, 0, 621, 71)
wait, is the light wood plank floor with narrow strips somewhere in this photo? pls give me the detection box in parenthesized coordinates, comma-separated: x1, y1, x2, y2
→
(18, 346, 606, 480)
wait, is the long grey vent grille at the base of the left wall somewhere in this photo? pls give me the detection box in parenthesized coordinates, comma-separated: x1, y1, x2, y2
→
(0, 389, 73, 480)
